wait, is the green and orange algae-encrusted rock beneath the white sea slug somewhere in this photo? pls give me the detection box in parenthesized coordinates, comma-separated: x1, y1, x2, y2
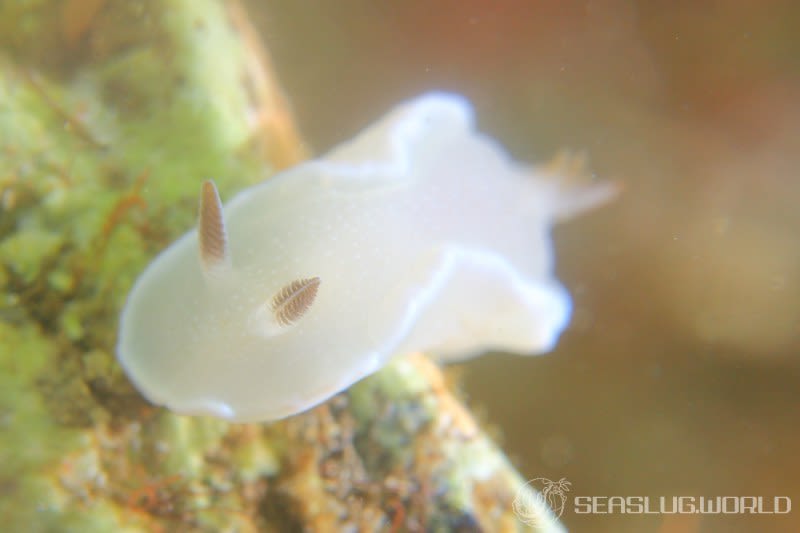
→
(0, 0, 558, 532)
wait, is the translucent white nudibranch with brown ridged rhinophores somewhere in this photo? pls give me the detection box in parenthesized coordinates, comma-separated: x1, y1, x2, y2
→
(117, 93, 614, 422)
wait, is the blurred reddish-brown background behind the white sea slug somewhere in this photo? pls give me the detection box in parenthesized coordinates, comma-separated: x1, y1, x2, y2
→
(249, 0, 800, 532)
